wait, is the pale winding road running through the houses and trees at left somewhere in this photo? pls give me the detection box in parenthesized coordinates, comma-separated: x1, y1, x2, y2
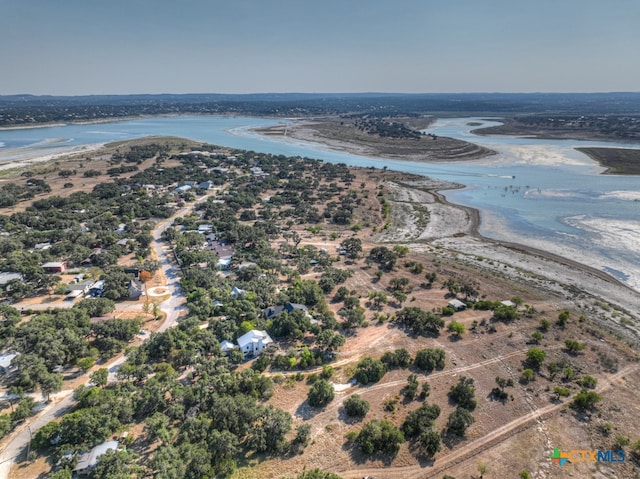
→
(0, 196, 207, 479)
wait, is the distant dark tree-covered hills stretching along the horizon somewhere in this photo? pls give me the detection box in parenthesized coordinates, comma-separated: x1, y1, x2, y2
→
(0, 92, 640, 126)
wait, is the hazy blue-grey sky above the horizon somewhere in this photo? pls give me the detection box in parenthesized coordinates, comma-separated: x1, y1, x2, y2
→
(0, 0, 640, 95)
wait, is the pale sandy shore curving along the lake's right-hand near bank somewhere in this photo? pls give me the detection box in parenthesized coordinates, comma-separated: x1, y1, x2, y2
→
(373, 178, 640, 342)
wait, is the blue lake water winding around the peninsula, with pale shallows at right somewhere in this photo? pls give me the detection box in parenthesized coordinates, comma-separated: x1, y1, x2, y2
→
(0, 116, 640, 289)
